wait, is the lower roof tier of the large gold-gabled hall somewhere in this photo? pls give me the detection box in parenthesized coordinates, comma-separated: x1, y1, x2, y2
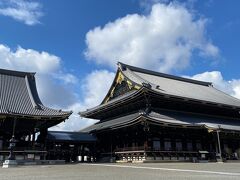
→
(81, 110, 240, 132)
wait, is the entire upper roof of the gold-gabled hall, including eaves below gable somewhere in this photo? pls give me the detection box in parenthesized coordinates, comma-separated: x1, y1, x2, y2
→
(79, 63, 240, 118)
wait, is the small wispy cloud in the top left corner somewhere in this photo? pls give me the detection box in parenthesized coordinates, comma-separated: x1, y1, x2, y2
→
(0, 0, 43, 25)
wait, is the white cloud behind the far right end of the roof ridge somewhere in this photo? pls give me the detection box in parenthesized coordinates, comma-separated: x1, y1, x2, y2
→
(188, 71, 240, 99)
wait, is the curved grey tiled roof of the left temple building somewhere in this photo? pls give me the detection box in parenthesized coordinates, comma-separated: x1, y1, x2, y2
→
(0, 69, 71, 117)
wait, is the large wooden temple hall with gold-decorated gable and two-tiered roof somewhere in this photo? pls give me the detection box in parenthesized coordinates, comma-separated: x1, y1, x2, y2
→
(80, 63, 240, 161)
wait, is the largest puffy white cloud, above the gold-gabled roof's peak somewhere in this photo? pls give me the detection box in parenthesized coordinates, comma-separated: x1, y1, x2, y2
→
(85, 3, 219, 72)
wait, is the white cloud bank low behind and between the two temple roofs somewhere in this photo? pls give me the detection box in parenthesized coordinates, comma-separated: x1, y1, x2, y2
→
(0, 44, 114, 131)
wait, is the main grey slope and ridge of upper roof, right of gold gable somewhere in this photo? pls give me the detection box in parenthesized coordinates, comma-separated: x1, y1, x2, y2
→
(119, 63, 240, 107)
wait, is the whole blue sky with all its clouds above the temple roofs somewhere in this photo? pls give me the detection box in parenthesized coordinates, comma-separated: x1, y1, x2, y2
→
(0, 0, 240, 130)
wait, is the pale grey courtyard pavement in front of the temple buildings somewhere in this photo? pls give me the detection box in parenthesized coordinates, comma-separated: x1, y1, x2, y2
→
(0, 163, 240, 180)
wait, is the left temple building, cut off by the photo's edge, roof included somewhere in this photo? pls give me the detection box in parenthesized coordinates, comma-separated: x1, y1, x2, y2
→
(0, 69, 72, 161)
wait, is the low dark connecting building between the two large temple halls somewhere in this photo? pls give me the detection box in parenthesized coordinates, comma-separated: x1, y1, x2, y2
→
(42, 131, 96, 162)
